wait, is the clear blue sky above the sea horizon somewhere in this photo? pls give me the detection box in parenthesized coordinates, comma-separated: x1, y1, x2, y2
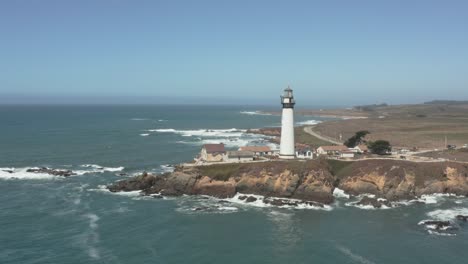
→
(0, 0, 468, 105)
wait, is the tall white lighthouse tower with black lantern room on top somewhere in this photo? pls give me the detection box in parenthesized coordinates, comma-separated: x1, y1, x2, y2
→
(280, 86, 296, 159)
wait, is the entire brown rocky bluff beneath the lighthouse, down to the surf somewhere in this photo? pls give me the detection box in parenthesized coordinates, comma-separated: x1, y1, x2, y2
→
(107, 159, 468, 204)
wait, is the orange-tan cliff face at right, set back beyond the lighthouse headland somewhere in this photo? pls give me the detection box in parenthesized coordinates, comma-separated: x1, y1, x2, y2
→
(337, 160, 468, 200)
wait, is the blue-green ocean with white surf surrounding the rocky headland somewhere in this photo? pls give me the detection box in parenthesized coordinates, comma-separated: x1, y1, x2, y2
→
(0, 105, 468, 264)
